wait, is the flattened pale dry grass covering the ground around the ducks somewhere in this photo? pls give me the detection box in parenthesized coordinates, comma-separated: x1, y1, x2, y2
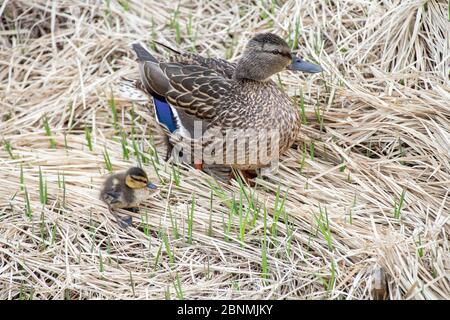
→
(0, 0, 450, 299)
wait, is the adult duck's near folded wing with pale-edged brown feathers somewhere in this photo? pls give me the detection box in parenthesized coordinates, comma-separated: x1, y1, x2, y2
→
(140, 61, 232, 120)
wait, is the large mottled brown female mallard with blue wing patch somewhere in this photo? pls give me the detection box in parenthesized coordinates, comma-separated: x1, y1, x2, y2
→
(132, 33, 322, 181)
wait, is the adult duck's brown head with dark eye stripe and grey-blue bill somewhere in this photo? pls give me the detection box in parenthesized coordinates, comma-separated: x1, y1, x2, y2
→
(234, 33, 322, 81)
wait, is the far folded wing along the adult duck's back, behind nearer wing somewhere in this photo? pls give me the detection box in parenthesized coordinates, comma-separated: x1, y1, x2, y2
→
(154, 41, 236, 79)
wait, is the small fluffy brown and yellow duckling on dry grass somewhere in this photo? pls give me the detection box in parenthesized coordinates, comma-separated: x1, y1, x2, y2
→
(100, 167, 157, 228)
